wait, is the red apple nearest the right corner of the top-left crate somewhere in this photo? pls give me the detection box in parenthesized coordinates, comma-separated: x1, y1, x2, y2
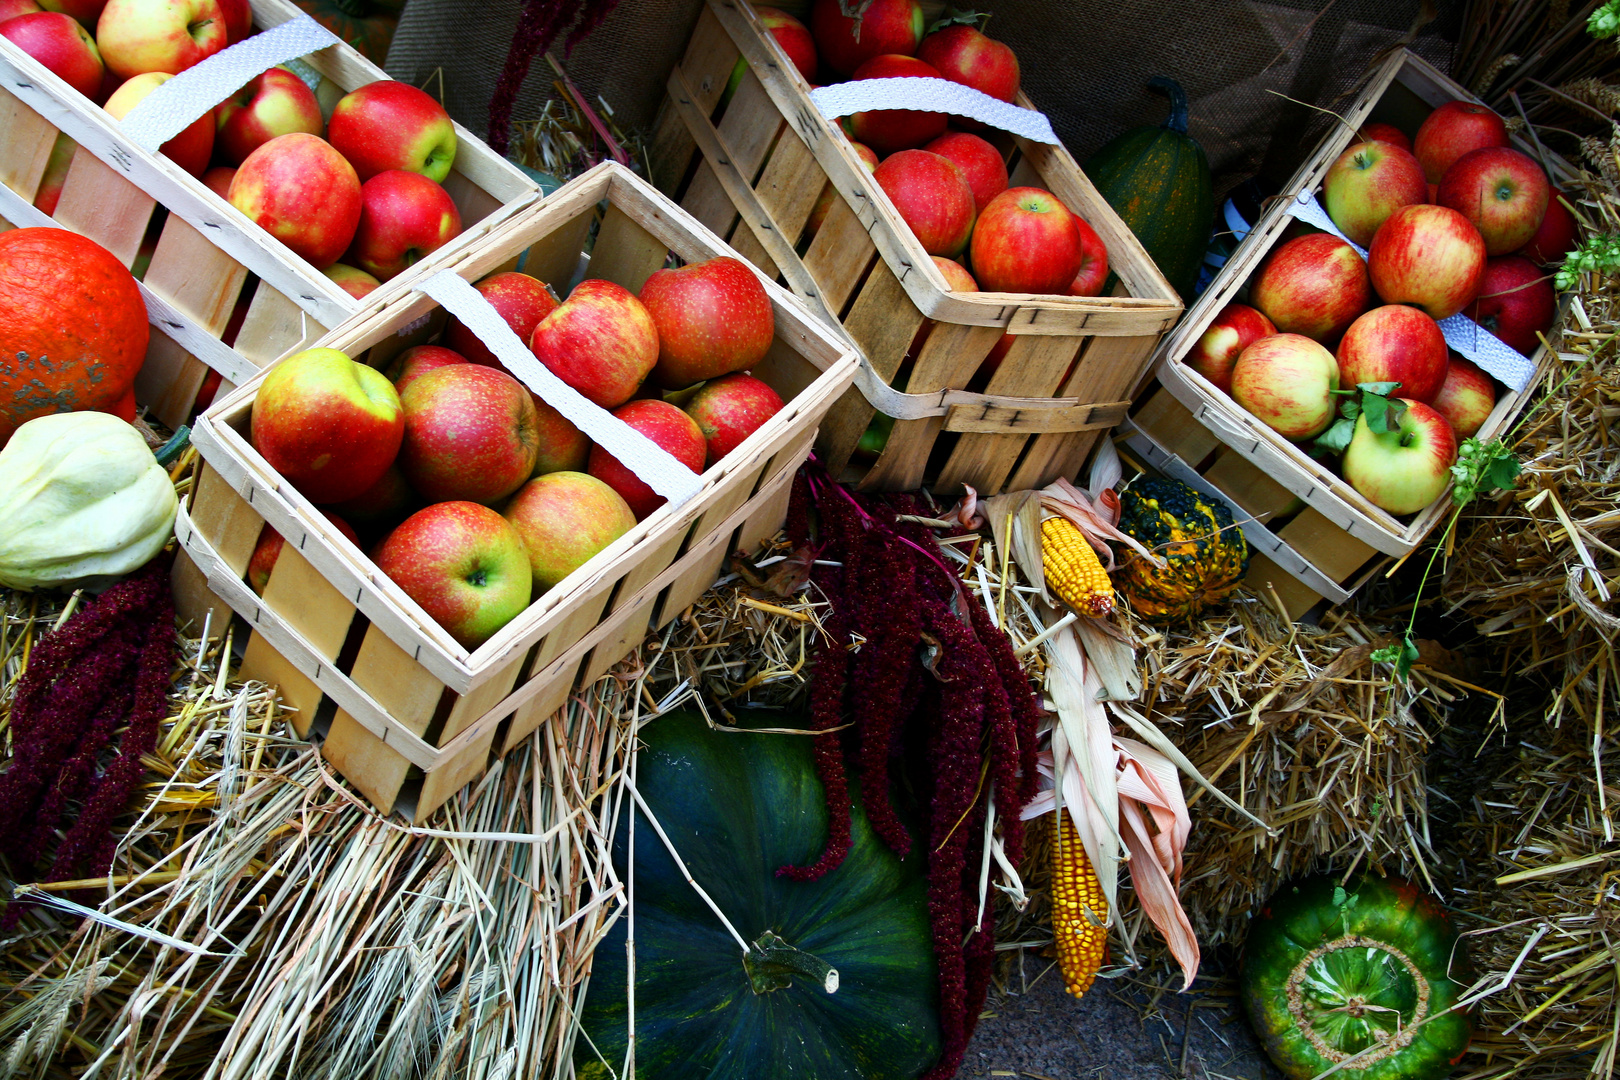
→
(345, 168, 462, 282)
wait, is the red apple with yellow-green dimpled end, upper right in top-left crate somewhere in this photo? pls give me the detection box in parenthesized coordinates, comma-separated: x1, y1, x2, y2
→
(326, 79, 455, 183)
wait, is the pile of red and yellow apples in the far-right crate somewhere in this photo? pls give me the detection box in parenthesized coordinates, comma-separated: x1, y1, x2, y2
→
(1187, 102, 1576, 515)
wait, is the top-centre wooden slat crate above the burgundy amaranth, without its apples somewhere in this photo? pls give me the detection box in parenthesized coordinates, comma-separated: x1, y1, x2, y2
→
(651, 0, 1181, 494)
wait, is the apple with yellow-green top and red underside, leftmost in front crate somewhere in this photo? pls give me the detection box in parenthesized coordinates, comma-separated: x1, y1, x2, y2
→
(251, 348, 405, 502)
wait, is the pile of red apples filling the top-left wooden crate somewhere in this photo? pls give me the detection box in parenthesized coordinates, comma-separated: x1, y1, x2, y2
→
(0, 0, 462, 296)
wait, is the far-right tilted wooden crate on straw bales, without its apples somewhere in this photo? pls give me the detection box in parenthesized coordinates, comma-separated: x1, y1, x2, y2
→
(1123, 50, 1570, 617)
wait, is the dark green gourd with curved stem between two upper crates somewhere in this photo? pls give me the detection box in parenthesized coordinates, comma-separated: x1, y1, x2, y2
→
(1085, 76, 1215, 300)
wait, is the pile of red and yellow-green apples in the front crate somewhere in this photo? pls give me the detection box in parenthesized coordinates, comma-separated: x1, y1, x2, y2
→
(248, 256, 782, 649)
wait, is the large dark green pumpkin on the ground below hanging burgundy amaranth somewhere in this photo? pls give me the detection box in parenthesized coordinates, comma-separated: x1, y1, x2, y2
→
(575, 712, 940, 1080)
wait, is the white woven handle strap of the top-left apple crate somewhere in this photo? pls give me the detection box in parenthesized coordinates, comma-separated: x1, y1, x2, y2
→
(118, 15, 340, 154)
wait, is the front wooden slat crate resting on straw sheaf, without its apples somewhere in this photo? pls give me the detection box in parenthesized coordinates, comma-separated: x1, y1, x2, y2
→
(175, 162, 857, 821)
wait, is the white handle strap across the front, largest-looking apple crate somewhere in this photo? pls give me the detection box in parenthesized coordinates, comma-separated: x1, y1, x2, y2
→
(416, 270, 703, 505)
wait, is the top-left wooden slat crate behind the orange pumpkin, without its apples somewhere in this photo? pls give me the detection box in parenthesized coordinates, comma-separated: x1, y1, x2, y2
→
(0, 0, 539, 427)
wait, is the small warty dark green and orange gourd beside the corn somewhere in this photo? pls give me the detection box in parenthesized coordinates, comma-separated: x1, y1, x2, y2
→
(1115, 476, 1249, 622)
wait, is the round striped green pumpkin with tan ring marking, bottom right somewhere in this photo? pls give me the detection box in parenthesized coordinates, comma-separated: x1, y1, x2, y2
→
(1238, 873, 1471, 1080)
